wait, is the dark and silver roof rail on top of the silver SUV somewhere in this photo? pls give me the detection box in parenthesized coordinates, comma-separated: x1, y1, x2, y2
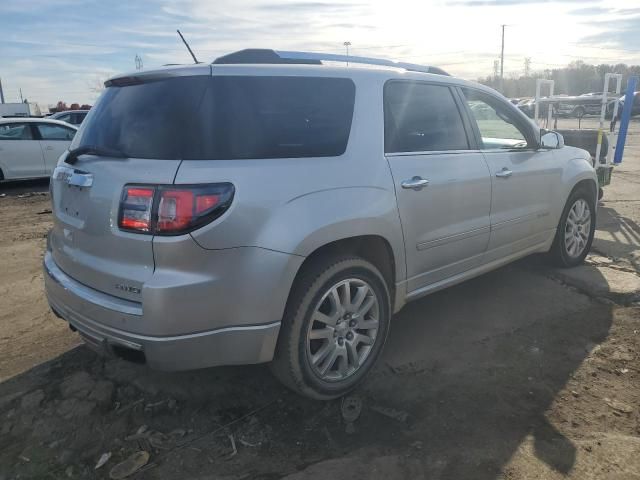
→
(213, 48, 449, 75)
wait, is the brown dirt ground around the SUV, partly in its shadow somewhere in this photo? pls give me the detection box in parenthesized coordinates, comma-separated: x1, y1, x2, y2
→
(0, 120, 640, 480)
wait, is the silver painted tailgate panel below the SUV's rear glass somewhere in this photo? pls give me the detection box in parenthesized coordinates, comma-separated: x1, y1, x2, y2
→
(50, 155, 180, 302)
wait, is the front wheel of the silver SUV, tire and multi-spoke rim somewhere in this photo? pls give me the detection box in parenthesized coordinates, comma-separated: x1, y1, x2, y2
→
(550, 188, 596, 268)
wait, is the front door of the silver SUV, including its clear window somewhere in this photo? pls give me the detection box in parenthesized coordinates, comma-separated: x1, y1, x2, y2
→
(461, 88, 562, 263)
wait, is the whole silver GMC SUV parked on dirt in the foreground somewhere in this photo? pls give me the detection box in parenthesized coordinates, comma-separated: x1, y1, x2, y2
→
(44, 51, 597, 399)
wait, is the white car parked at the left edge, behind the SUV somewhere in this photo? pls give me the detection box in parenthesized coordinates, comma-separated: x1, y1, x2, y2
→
(0, 118, 78, 180)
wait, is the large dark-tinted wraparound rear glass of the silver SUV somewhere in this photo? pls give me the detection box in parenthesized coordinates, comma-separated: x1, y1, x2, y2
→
(73, 76, 355, 160)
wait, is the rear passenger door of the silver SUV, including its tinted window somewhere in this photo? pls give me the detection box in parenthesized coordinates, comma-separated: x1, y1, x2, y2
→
(384, 80, 491, 295)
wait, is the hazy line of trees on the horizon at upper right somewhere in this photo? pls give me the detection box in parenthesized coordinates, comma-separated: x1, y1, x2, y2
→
(478, 60, 640, 98)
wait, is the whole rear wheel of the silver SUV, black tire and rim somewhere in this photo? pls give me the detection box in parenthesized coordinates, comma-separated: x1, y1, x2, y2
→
(271, 255, 391, 400)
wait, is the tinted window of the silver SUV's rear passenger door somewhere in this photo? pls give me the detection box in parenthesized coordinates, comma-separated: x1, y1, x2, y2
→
(384, 81, 469, 153)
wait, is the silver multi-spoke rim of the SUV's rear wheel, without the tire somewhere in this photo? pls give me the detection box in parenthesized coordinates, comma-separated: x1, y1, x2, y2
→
(307, 278, 380, 382)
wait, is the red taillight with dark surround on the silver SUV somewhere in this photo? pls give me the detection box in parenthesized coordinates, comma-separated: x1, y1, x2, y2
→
(118, 183, 235, 235)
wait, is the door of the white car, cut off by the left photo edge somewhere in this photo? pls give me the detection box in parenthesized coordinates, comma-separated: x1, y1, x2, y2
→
(0, 122, 45, 180)
